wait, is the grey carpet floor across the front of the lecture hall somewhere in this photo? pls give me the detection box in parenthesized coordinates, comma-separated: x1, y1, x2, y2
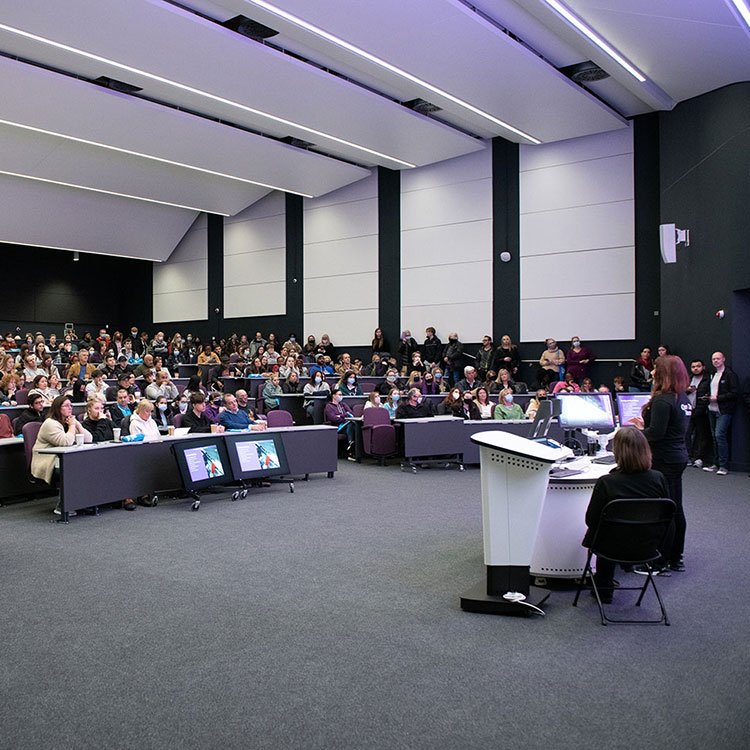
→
(0, 462, 750, 750)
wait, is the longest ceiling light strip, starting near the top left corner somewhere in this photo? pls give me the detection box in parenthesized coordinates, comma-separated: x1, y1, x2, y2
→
(0, 23, 416, 167)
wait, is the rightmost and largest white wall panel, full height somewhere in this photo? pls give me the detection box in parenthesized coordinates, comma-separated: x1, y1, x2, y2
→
(520, 129, 635, 342)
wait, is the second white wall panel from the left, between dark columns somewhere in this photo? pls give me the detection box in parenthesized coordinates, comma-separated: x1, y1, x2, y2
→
(224, 192, 286, 318)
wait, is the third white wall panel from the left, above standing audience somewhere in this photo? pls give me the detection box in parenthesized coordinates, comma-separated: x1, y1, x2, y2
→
(303, 174, 378, 348)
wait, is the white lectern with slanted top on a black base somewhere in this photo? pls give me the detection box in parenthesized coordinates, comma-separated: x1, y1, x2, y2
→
(461, 431, 570, 615)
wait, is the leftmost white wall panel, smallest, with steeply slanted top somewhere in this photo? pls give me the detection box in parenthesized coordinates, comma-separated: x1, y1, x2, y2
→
(153, 214, 208, 323)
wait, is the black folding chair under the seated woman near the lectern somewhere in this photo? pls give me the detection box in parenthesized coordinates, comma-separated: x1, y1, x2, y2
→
(573, 498, 675, 625)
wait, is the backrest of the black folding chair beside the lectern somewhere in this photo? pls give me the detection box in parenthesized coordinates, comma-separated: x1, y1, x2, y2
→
(590, 498, 675, 565)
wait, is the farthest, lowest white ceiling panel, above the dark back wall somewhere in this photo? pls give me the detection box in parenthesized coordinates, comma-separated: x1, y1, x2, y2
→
(0, 175, 196, 261)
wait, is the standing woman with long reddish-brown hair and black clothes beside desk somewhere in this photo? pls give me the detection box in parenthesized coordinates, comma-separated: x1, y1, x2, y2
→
(632, 354, 692, 575)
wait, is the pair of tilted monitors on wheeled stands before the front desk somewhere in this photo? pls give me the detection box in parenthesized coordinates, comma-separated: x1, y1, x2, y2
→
(172, 433, 289, 510)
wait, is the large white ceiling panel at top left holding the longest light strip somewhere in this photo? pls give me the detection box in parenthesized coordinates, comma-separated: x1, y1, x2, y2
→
(0, 0, 481, 168)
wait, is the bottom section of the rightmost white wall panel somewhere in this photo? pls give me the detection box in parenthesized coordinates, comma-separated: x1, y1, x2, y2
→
(521, 293, 635, 342)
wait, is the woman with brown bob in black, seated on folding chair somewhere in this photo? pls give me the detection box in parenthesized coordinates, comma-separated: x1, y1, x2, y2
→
(581, 427, 669, 604)
